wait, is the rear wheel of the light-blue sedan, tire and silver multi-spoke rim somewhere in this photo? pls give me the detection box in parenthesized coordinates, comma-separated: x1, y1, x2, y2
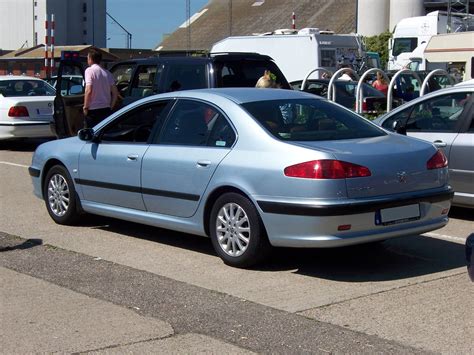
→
(209, 192, 272, 268)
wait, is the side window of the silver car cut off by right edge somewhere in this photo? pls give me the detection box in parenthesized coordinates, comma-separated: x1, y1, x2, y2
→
(406, 93, 469, 132)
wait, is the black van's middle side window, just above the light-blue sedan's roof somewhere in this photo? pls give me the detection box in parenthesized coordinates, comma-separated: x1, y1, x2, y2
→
(163, 62, 209, 92)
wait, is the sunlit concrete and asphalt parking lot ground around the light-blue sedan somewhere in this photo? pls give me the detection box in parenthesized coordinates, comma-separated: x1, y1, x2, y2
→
(0, 141, 474, 353)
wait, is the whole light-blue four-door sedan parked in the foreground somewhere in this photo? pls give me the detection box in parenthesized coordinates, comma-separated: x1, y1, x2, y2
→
(30, 89, 452, 267)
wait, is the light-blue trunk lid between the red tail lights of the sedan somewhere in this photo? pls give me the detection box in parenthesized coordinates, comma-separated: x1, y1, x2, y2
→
(297, 134, 447, 198)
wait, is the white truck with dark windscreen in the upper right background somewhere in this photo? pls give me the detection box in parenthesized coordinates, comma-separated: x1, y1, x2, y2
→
(387, 11, 463, 70)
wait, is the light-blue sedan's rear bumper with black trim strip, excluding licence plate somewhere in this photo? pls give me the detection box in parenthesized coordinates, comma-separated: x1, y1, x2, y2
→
(257, 188, 453, 248)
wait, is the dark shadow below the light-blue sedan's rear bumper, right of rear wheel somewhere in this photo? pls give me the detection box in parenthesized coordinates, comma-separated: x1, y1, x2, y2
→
(262, 235, 466, 282)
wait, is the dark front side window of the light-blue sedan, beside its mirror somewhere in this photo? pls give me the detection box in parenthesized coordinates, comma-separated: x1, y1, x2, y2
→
(101, 101, 168, 143)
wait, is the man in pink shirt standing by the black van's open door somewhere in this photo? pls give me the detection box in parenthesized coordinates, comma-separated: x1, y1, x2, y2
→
(83, 49, 118, 127)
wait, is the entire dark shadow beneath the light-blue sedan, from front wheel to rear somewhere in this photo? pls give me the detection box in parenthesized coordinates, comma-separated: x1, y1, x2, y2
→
(83, 216, 466, 282)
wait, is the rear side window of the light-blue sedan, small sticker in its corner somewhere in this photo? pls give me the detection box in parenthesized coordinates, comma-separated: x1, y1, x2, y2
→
(159, 100, 235, 148)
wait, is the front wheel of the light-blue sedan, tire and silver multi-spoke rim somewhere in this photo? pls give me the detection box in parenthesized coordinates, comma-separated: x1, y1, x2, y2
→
(43, 165, 79, 225)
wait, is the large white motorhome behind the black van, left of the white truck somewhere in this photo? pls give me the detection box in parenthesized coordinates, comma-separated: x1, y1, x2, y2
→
(211, 28, 365, 82)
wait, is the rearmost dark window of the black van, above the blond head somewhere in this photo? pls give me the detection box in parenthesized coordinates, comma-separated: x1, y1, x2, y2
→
(214, 59, 290, 89)
